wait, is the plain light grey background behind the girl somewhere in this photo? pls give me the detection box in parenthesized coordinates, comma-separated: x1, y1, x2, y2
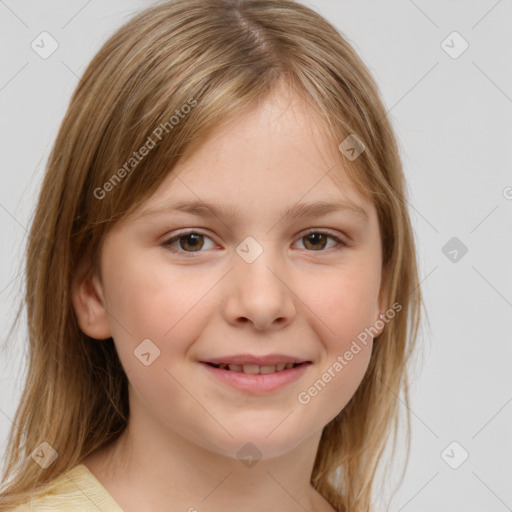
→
(0, 0, 512, 512)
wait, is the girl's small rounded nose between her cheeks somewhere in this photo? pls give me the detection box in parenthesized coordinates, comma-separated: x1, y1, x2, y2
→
(224, 247, 296, 331)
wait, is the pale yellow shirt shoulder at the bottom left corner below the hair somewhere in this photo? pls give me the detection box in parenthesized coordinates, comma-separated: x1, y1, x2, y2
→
(13, 464, 123, 512)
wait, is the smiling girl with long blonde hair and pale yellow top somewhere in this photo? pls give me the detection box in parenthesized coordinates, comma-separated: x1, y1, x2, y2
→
(0, 0, 421, 512)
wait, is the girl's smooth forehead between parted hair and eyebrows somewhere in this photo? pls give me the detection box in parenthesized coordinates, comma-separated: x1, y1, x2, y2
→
(136, 84, 373, 220)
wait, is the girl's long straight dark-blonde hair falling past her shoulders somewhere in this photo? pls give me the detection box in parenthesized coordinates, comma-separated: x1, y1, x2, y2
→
(0, 0, 422, 512)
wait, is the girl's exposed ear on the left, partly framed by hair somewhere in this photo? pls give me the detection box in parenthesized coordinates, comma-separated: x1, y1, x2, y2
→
(71, 263, 112, 340)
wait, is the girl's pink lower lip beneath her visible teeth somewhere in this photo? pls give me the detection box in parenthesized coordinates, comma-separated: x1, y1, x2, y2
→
(201, 363, 310, 394)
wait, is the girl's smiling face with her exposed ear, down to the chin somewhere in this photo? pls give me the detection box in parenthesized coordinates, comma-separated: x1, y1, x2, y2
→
(74, 84, 384, 457)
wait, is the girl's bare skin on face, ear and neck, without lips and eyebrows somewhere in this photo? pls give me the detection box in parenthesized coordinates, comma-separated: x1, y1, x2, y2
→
(73, 82, 386, 512)
